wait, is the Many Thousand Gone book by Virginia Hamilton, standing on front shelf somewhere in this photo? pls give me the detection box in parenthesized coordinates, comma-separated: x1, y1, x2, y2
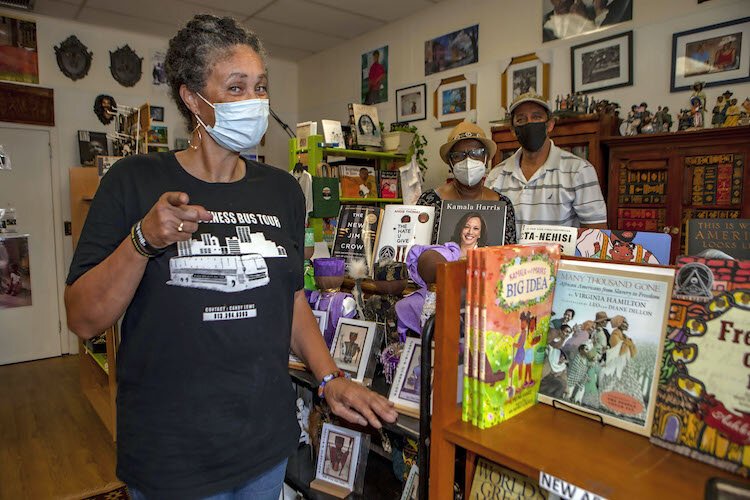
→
(539, 259, 674, 435)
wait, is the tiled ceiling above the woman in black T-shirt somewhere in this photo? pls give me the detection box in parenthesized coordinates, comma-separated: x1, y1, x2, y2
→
(33, 0, 441, 61)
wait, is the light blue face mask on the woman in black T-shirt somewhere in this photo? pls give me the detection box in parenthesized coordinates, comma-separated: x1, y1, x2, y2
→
(196, 94, 269, 153)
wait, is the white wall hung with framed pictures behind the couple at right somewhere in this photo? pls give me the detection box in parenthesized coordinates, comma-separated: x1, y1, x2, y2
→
(299, 0, 750, 187)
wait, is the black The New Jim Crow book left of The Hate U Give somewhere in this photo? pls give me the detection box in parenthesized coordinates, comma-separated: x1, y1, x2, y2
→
(331, 205, 383, 275)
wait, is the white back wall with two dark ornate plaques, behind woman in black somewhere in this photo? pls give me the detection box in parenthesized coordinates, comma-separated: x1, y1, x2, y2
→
(0, 9, 297, 352)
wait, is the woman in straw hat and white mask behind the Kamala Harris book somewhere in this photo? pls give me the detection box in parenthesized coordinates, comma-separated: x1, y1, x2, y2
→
(417, 122, 516, 245)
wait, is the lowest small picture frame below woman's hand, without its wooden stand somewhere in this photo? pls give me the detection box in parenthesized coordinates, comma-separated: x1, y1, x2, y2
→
(315, 423, 362, 492)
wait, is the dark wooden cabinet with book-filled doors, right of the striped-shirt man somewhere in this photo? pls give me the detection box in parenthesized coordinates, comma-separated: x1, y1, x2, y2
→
(603, 127, 750, 262)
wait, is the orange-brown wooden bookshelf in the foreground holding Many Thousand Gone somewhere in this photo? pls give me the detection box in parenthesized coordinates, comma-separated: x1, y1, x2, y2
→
(429, 262, 738, 499)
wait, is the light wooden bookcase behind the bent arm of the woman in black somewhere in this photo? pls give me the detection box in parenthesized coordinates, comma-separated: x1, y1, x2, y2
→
(70, 167, 119, 440)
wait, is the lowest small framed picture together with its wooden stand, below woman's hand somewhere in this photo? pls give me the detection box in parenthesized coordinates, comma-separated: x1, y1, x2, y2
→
(310, 423, 369, 498)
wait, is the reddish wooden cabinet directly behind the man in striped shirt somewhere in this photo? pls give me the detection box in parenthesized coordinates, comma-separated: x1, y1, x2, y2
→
(492, 114, 620, 193)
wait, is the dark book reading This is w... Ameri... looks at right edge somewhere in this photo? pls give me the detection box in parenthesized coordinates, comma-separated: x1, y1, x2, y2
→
(685, 219, 750, 259)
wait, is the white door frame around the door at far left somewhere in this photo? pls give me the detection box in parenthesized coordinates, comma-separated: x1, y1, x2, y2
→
(0, 121, 69, 354)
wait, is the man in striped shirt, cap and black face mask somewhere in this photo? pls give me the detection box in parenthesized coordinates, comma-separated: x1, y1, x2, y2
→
(485, 93, 607, 234)
